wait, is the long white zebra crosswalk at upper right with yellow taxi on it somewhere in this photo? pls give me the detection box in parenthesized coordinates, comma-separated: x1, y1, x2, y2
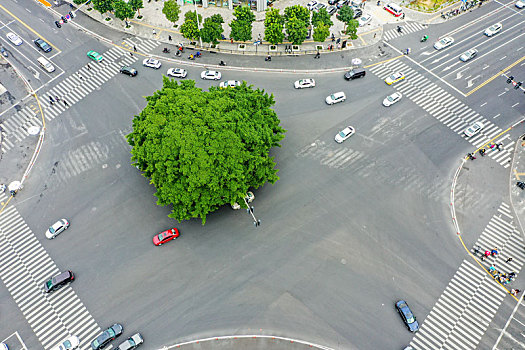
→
(370, 60, 515, 168)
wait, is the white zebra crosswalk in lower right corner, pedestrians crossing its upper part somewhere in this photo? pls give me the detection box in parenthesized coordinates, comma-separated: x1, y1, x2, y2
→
(410, 203, 525, 350)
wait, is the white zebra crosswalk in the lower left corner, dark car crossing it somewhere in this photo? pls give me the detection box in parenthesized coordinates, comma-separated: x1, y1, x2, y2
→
(0, 194, 101, 350)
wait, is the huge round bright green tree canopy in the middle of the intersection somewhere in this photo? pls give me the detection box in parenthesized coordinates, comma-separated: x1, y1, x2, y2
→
(127, 77, 285, 225)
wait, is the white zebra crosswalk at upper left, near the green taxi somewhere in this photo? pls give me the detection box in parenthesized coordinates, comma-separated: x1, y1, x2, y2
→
(0, 38, 160, 153)
